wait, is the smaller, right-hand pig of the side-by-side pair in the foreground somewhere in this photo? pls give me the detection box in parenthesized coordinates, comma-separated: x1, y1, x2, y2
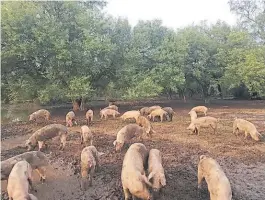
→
(148, 149, 166, 193)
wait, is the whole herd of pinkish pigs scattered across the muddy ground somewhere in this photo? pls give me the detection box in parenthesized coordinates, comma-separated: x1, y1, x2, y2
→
(1, 105, 261, 200)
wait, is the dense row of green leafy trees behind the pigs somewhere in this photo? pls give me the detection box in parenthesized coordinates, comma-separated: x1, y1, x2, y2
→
(1, 0, 265, 103)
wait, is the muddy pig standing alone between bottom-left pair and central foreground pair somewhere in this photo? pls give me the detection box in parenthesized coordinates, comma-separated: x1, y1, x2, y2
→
(81, 146, 104, 190)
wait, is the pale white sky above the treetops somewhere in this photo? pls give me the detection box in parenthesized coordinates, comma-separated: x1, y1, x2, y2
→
(105, 0, 236, 28)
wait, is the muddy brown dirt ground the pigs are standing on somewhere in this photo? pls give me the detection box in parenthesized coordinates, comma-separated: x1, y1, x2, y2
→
(1, 100, 265, 200)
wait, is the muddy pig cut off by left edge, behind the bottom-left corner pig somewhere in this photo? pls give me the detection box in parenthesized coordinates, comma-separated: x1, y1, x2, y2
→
(1, 151, 49, 182)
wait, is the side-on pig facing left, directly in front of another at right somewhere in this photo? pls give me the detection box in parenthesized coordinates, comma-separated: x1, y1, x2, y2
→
(187, 116, 218, 135)
